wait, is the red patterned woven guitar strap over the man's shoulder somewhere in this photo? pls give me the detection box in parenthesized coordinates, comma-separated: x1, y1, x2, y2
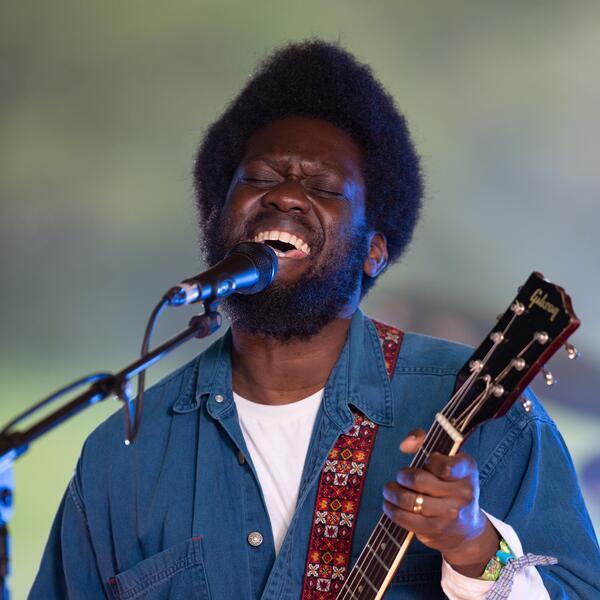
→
(301, 321, 404, 600)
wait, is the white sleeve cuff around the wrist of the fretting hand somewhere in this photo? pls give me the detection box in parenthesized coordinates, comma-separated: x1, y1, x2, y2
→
(441, 511, 550, 600)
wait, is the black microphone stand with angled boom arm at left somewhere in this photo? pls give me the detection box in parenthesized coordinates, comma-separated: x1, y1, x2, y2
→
(0, 301, 221, 600)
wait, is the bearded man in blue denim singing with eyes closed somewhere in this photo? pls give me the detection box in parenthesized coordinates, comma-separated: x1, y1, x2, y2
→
(31, 41, 600, 600)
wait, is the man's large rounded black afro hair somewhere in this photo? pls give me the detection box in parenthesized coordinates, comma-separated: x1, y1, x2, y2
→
(194, 40, 423, 294)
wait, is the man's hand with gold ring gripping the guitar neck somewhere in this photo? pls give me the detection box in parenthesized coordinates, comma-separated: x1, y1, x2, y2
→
(383, 429, 500, 577)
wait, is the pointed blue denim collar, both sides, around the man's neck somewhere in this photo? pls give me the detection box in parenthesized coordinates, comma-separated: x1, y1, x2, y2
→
(173, 310, 393, 431)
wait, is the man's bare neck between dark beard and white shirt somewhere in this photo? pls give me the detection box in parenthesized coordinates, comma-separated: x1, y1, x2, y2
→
(231, 316, 351, 405)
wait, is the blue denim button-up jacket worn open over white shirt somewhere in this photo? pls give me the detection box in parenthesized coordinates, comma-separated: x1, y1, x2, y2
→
(30, 311, 600, 600)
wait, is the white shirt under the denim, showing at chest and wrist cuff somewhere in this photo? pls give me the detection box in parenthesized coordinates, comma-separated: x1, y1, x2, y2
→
(233, 390, 550, 600)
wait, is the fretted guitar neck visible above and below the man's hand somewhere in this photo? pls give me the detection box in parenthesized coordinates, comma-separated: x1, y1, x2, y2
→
(337, 420, 462, 600)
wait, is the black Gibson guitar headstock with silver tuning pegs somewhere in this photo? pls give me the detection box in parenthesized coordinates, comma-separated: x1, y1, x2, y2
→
(452, 272, 580, 437)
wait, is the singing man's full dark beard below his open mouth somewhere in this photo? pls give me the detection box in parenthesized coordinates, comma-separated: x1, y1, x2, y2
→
(205, 216, 369, 342)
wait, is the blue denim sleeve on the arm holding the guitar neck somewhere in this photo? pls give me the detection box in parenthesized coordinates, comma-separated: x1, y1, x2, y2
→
(480, 395, 600, 599)
